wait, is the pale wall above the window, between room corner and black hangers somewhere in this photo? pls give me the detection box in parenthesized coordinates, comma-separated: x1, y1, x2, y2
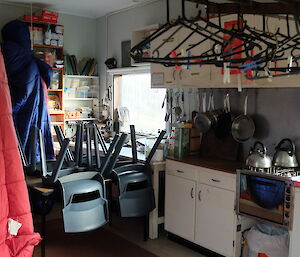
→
(97, 0, 204, 100)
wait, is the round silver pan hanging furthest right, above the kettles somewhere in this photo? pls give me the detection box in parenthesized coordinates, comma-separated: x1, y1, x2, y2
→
(231, 94, 255, 143)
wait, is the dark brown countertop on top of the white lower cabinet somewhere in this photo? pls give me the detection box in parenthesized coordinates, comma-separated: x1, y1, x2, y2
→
(167, 155, 244, 174)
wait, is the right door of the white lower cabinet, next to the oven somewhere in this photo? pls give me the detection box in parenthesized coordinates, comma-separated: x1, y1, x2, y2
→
(195, 184, 235, 257)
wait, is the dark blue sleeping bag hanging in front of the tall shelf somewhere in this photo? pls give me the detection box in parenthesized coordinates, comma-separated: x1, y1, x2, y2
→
(2, 20, 54, 161)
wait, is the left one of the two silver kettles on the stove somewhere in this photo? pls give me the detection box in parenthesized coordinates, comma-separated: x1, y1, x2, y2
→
(246, 141, 272, 169)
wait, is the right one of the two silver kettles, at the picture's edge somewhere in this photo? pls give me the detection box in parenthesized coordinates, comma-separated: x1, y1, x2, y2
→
(273, 138, 299, 168)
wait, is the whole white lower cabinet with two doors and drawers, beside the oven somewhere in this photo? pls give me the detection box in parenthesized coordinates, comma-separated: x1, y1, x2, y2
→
(165, 159, 244, 257)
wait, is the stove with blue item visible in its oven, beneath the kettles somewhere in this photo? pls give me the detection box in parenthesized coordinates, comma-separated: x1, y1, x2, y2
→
(236, 167, 300, 230)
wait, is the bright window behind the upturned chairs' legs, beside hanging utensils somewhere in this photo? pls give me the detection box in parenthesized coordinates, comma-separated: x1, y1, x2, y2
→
(114, 73, 166, 134)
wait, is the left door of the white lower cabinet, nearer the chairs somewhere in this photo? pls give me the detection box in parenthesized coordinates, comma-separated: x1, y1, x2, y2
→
(165, 174, 196, 241)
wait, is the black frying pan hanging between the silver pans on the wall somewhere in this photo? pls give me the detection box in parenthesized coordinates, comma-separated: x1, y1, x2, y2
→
(215, 93, 232, 139)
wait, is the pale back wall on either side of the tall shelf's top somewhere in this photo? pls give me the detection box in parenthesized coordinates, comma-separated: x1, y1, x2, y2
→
(0, 3, 97, 59)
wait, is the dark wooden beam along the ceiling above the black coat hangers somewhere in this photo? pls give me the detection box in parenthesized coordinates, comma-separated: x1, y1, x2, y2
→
(188, 0, 300, 15)
